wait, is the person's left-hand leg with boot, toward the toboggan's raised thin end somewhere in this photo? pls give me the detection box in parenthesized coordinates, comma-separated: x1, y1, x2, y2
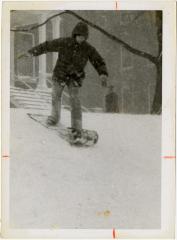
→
(47, 81, 64, 125)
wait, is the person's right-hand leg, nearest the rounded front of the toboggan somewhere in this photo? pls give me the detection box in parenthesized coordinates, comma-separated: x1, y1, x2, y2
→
(68, 84, 82, 131)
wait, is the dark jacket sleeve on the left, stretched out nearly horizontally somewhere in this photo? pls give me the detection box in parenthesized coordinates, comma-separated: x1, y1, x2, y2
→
(28, 38, 64, 56)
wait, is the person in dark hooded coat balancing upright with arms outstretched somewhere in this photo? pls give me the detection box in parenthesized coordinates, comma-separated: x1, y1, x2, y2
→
(28, 22, 108, 141)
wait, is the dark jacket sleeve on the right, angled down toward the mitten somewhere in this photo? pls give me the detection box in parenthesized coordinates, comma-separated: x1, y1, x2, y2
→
(89, 46, 108, 76)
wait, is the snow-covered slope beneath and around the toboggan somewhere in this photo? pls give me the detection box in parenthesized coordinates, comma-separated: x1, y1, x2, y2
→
(10, 109, 161, 229)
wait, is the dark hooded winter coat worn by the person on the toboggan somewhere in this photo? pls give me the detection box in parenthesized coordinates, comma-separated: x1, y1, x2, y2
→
(28, 22, 108, 85)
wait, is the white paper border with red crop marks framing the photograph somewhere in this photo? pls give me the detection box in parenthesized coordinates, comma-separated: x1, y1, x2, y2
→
(1, 0, 176, 239)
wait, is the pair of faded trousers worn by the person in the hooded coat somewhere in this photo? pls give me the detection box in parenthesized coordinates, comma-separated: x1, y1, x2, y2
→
(51, 81, 82, 130)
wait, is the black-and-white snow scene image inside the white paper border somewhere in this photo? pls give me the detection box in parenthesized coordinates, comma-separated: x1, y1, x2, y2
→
(2, 2, 174, 238)
